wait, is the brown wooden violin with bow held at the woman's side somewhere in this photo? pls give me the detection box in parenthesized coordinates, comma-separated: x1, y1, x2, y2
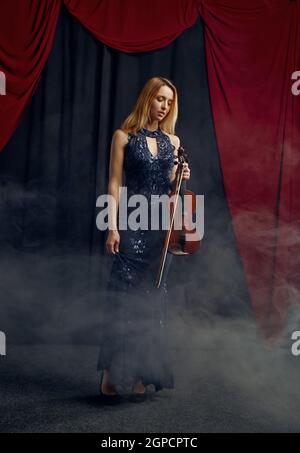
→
(156, 146, 201, 288)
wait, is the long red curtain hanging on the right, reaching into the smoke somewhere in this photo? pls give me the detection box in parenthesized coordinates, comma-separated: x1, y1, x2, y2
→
(201, 0, 300, 335)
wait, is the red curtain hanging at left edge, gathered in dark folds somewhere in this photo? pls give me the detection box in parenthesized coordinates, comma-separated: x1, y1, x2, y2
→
(0, 0, 61, 150)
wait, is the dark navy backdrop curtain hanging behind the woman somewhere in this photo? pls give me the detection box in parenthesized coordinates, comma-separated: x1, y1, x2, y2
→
(0, 7, 252, 344)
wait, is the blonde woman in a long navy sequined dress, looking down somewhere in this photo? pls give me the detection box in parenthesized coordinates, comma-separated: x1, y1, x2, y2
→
(98, 77, 190, 396)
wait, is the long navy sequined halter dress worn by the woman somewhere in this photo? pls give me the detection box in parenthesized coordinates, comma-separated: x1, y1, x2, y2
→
(97, 128, 174, 393)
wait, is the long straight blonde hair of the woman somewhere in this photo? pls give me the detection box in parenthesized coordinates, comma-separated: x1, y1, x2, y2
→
(121, 77, 178, 135)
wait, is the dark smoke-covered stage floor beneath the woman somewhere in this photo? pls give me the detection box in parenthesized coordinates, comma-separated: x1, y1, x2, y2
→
(0, 345, 300, 433)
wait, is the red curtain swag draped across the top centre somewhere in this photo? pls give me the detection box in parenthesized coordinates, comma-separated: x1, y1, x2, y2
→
(64, 0, 199, 52)
